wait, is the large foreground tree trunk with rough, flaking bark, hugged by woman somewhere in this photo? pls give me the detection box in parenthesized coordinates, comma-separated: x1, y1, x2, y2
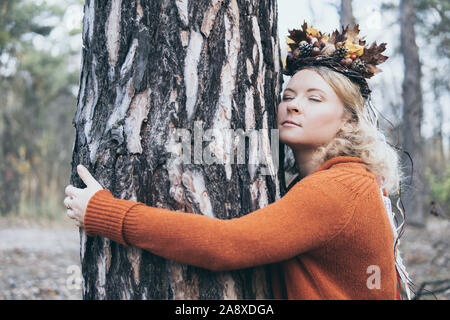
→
(72, 0, 285, 299)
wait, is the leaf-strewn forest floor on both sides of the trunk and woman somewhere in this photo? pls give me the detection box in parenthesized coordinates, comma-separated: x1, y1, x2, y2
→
(0, 217, 450, 300)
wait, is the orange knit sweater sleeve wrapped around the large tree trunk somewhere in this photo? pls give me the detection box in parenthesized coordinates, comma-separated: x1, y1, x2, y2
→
(84, 174, 354, 271)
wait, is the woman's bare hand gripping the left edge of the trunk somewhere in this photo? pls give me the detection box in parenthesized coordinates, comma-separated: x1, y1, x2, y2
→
(64, 164, 103, 227)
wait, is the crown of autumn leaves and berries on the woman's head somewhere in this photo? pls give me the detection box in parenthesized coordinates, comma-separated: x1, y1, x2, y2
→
(283, 22, 388, 99)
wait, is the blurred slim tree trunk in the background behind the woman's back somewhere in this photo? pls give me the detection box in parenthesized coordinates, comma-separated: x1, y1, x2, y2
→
(400, 0, 427, 226)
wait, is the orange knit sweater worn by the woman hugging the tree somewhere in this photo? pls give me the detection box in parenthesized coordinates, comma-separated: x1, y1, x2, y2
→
(84, 156, 397, 299)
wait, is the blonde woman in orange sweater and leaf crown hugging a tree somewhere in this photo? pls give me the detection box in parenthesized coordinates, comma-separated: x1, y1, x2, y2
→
(64, 24, 412, 299)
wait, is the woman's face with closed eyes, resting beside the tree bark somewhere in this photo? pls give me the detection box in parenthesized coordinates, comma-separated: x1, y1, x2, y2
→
(277, 69, 344, 150)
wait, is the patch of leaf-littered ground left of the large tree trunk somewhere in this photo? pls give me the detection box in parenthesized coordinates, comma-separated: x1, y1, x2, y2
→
(0, 218, 81, 300)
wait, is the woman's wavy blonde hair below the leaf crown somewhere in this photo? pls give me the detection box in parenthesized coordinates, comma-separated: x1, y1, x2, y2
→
(290, 66, 405, 194)
